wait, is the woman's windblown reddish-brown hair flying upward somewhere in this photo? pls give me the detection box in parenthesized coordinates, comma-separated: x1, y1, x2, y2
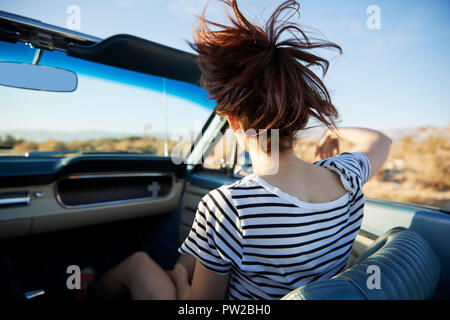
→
(190, 0, 342, 152)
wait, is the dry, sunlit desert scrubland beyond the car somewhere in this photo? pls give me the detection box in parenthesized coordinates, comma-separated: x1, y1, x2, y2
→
(0, 125, 450, 209)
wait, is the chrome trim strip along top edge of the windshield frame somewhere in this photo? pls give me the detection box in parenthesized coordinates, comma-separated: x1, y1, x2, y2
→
(0, 10, 102, 43)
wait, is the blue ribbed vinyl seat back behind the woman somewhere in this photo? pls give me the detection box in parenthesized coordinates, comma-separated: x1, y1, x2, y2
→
(283, 228, 441, 300)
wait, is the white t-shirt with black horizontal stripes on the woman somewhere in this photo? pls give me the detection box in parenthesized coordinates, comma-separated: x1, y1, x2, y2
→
(179, 152, 370, 300)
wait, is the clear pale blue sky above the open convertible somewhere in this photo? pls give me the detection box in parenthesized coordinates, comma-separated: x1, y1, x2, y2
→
(0, 0, 450, 136)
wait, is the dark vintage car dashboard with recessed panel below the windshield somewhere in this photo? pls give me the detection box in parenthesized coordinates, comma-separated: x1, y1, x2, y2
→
(0, 154, 186, 238)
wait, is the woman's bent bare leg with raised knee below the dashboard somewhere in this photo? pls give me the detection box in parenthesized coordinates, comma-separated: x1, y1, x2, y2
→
(88, 252, 177, 300)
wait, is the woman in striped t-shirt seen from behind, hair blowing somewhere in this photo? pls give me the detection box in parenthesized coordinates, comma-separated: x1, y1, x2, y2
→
(88, 0, 391, 299)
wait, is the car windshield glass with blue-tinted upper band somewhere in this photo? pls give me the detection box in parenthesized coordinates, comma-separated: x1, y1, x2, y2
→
(0, 42, 213, 156)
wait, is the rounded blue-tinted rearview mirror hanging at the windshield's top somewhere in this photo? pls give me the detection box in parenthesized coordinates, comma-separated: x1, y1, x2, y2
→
(0, 61, 78, 92)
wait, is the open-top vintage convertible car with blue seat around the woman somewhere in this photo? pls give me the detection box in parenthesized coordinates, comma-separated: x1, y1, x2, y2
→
(0, 11, 450, 300)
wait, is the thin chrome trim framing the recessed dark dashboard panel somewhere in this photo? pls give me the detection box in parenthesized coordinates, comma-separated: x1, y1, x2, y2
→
(53, 172, 175, 209)
